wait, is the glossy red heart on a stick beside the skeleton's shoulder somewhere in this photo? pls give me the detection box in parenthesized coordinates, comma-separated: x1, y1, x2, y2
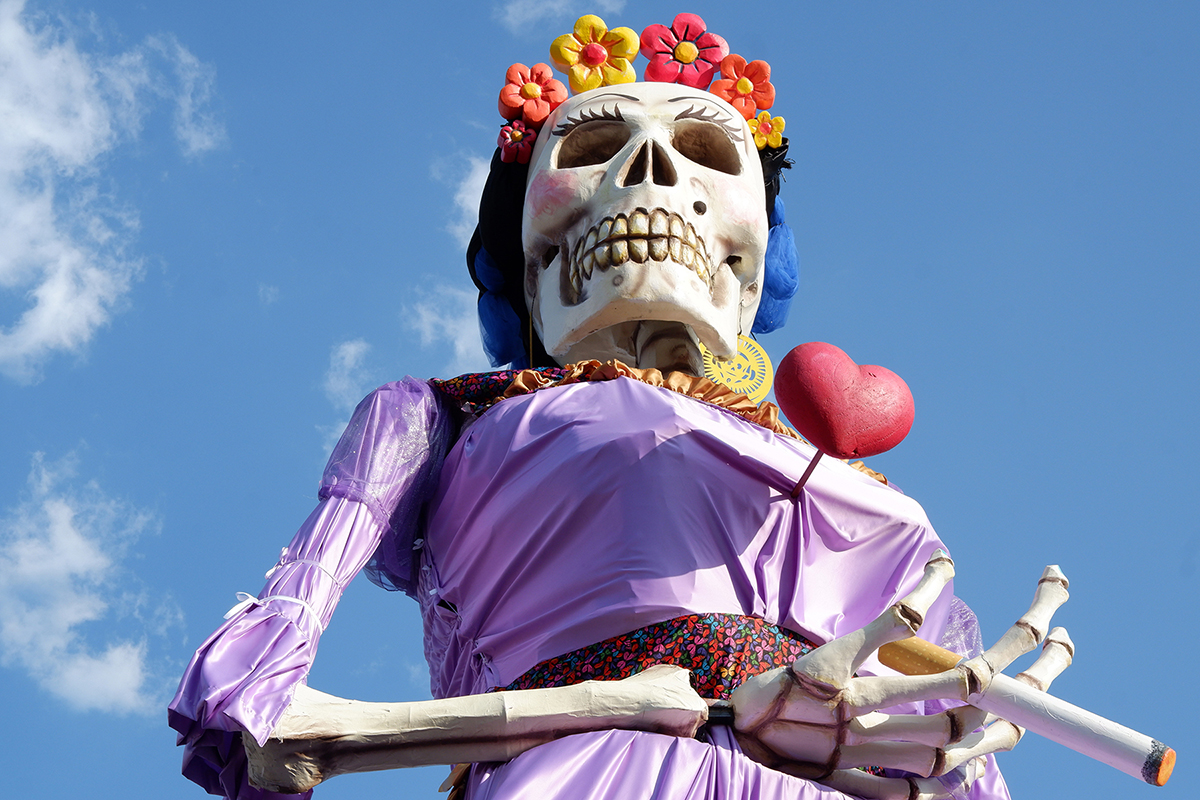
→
(775, 342, 914, 458)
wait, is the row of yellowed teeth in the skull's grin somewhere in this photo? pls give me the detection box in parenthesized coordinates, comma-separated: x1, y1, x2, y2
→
(563, 209, 713, 305)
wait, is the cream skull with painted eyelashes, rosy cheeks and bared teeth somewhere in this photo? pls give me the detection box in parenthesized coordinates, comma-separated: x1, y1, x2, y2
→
(522, 83, 767, 366)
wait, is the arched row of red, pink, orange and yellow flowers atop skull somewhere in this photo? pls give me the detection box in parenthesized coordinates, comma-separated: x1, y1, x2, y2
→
(497, 13, 785, 164)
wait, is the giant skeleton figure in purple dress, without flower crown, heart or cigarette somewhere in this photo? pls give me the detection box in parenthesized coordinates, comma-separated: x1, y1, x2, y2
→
(170, 10, 1104, 800)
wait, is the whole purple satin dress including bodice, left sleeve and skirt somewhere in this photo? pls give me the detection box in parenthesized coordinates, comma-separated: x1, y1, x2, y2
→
(170, 378, 1008, 800)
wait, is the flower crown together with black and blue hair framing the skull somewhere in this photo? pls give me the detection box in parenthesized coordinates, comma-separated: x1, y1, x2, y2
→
(467, 13, 799, 368)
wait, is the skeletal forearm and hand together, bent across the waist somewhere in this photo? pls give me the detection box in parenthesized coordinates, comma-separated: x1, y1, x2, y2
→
(238, 555, 1128, 800)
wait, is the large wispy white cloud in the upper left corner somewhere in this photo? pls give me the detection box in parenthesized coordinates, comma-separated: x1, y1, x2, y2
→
(0, 0, 224, 383)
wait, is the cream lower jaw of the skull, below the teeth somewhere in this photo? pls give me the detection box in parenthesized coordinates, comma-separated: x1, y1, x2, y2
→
(530, 253, 757, 374)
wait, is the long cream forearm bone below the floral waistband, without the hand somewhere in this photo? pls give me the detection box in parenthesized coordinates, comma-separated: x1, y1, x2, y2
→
(246, 664, 708, 793)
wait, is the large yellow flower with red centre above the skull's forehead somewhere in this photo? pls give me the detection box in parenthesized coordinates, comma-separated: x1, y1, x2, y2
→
(550, 14, 641, 95)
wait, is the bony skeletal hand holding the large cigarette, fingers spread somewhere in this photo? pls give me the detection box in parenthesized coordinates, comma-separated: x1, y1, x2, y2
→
(731, 551, 1073, 800)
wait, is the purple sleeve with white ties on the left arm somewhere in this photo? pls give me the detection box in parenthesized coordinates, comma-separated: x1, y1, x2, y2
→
(168, 378, 454, 800)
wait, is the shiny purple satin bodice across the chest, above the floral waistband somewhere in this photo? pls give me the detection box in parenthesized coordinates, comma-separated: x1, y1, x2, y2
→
(418, 378, 952, 697)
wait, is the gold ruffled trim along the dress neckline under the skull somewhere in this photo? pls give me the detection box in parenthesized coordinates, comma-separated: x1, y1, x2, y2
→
(497, 360, 888, 485)
